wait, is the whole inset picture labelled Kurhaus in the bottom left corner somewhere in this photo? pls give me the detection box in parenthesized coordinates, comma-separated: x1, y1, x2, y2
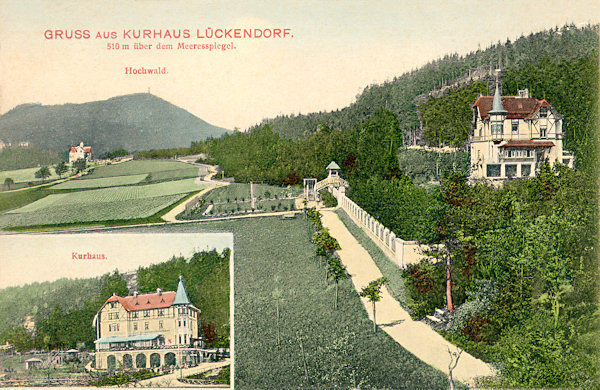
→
(0, 233, 233, 387)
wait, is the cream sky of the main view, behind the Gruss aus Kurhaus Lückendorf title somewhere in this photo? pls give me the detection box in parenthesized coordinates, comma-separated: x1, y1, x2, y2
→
(0, 0, 600, 130)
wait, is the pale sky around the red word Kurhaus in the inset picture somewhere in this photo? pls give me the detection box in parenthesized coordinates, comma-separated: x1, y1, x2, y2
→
(0, 233, 233, 289)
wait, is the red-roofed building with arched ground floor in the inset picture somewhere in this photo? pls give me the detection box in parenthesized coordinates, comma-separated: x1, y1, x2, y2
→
(93, 277, 204, 371)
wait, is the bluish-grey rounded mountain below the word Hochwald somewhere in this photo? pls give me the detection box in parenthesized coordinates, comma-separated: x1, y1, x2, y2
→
(0, 93, 227, 156)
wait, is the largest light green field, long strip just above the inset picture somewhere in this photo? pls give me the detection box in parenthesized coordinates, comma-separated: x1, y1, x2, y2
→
(0, 179, 203, 227)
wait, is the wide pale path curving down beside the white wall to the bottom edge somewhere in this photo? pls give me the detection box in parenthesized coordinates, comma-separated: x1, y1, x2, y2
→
(322, 210, 494, 385)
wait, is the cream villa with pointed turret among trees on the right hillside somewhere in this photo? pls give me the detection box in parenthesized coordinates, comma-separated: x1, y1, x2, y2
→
(469, 83, 574, 182)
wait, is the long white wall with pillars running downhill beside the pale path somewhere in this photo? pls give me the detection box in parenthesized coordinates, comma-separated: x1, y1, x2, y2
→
(331, 187, 425, 268)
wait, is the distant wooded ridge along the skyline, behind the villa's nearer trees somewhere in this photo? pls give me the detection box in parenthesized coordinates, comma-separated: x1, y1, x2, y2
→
(251, 25, 598, 138)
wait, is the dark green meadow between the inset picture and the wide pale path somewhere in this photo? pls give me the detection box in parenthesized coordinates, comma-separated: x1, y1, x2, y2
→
(122, 217, 447, 389)
